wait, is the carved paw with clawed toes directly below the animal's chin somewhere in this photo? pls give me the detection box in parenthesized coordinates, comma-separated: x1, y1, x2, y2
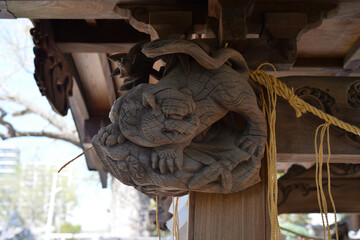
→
(151, 147, 183, 174)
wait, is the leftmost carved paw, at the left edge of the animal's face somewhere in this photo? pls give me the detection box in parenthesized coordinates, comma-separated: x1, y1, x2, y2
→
(98, 123, 125, 147)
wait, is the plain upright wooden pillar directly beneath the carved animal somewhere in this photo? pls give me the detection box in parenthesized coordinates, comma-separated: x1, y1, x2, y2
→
(188, 161, 270, 240)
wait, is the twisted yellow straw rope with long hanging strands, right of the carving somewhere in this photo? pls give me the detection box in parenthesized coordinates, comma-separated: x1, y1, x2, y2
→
(250, 63, 354, 240)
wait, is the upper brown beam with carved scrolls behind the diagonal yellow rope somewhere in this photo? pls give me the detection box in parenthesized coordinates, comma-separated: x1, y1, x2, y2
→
(276, 77, 360, 162)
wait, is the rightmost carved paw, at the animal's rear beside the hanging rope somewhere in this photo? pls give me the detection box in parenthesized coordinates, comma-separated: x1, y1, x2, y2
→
(235, 135, 266, 157)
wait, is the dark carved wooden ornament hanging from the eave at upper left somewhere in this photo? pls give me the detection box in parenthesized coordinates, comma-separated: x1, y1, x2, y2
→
(30, 20, 73, 116)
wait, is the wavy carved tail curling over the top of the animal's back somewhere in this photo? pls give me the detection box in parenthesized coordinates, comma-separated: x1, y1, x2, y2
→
(142, 39, 249, 74)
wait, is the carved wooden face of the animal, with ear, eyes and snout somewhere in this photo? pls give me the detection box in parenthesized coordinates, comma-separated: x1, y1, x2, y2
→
(110, 84, 199, 147)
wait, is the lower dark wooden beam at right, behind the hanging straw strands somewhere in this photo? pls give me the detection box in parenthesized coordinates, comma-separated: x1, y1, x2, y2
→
(278, 164, 360, 214)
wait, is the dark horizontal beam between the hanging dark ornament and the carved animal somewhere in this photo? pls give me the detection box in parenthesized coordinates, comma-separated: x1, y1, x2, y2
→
(50, 19, 150, 53)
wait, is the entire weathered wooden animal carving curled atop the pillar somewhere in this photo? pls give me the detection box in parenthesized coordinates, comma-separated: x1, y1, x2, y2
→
(92, 39, 267, 196)
